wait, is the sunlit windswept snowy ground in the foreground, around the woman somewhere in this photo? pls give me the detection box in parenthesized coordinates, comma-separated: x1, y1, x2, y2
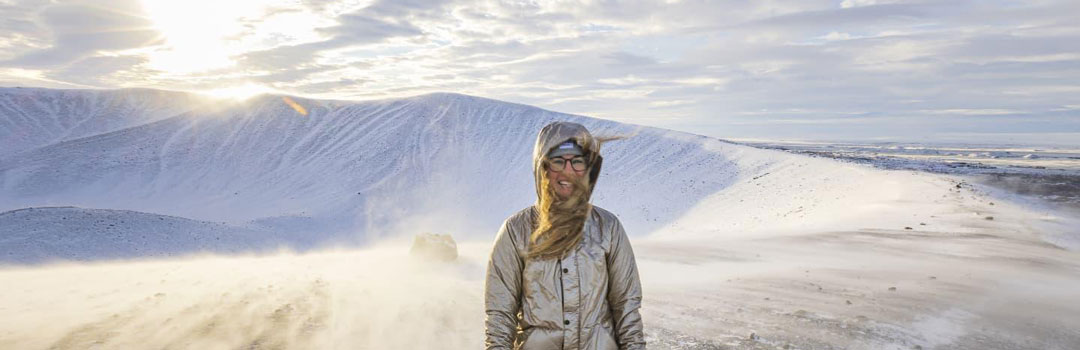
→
(0, 173, 1080, 349)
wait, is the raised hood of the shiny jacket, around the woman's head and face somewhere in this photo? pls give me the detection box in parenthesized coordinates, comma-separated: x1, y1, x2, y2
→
(532, 122, 604, 200)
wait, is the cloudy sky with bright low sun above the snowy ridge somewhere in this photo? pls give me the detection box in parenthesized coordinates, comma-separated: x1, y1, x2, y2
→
(0, 0, 1080, 146)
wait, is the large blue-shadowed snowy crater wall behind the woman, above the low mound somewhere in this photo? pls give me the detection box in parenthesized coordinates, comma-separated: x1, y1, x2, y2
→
(0, 91, 739, 245)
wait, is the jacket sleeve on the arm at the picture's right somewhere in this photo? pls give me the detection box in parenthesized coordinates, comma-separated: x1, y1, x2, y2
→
(607, 220, 645, 350)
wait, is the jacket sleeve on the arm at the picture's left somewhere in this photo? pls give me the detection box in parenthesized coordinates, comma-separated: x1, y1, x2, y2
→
(484, 219, 524, 350)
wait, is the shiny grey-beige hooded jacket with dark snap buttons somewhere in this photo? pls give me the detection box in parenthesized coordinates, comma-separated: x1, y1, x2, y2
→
(484, 122, 645, 350)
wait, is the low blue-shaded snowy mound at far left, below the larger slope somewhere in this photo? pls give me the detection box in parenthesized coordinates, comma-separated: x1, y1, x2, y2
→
(0, 206, 308, 264)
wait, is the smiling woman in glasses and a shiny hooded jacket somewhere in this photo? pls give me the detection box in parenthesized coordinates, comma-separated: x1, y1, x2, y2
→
(484, 122, 645, 350)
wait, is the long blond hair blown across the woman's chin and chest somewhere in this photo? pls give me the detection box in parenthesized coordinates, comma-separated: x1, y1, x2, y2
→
(527, 166, 593, 259)
